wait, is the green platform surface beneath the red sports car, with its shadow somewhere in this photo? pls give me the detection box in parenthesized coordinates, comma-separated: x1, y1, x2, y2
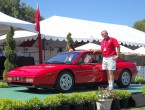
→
(0, 84, 145, 101)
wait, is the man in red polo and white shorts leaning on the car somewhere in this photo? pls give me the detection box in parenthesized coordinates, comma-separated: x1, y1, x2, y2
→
(94, 30, 120, 90)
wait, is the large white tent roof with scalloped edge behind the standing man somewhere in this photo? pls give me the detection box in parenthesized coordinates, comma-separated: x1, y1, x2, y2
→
(40, 16, 145, 46)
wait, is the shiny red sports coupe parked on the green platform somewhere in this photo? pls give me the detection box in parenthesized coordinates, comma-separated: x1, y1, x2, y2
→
(6, 51, 137, 92)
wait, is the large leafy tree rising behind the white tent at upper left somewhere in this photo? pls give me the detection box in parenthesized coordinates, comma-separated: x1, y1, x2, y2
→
(0, 0, 44, 23)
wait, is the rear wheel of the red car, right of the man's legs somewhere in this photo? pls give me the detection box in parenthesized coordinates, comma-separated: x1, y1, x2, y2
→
(116, 70, 131, 88)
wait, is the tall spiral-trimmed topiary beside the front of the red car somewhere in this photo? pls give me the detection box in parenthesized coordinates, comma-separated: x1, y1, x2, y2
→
(3, 26, 17, 81)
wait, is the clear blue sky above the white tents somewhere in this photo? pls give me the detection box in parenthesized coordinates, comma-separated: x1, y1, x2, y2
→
(20, 0, 145, 27)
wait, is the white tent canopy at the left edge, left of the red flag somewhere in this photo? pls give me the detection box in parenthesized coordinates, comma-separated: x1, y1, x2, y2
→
(0, 12, 36, 35)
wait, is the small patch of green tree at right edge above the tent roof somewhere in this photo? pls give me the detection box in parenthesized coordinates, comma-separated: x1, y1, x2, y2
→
(133, 19, 145, 32)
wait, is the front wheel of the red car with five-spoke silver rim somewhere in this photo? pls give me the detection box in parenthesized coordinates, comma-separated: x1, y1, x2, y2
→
(55, 70, 74, 93)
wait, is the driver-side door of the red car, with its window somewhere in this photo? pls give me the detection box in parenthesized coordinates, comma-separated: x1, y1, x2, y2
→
(76, 53, 97, 83)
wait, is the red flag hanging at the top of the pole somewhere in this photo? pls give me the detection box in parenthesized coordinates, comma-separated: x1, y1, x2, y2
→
(35, 5, 40, 32)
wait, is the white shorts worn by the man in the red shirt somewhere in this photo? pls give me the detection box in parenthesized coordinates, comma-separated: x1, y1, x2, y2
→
(102, 56, 116, 70)
